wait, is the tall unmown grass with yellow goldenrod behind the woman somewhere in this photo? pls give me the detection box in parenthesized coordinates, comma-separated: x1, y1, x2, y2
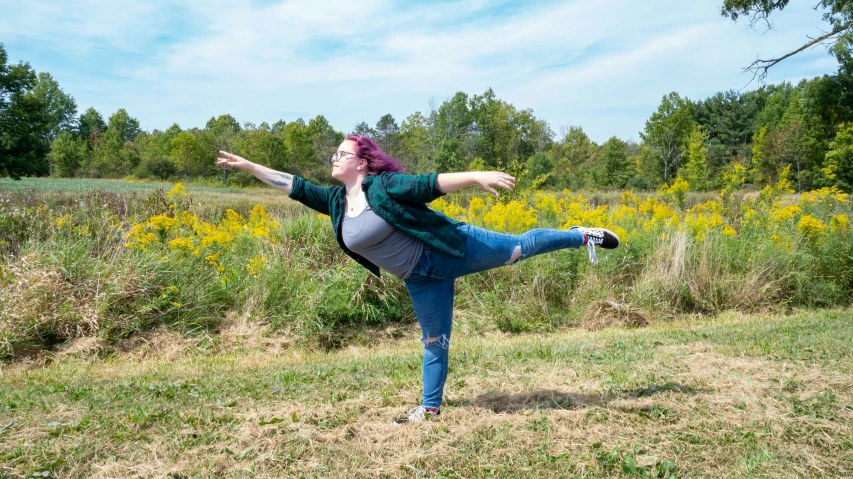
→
(0, 180, 853, 358)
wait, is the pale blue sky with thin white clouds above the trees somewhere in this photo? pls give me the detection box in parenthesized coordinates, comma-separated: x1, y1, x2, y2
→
(0, 0, 837, 143)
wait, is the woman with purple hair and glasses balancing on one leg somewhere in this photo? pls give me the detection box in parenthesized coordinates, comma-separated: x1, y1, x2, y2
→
(217, 135, 619, 423)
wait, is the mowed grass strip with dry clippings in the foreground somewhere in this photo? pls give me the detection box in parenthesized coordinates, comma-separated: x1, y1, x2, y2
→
(0, 310, 853, 478)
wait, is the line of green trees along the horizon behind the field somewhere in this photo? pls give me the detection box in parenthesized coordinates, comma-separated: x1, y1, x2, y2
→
(0, 43, 853, 191)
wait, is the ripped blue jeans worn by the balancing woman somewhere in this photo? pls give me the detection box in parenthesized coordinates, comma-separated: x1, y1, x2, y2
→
(405, 224, 584, 408)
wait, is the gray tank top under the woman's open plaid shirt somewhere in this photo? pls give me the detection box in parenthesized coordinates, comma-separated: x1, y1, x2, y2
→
(341, 206, 424, 279)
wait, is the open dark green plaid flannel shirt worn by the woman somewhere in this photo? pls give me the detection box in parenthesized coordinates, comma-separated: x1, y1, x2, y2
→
(290, 172, 465, 276)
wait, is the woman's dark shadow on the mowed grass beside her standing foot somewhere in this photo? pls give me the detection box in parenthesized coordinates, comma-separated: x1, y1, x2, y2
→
(446, 383, 708, 412)
